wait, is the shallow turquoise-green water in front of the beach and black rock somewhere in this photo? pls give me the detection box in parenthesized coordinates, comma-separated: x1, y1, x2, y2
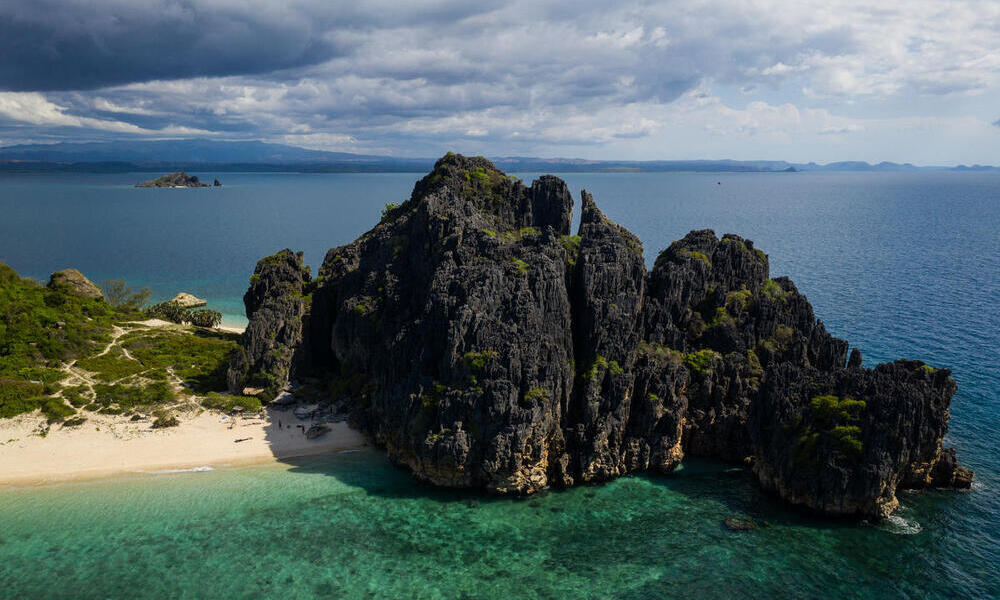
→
(0, 451, 997, 598)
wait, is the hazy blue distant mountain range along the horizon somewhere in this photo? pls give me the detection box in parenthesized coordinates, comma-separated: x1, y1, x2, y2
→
(0, 140, 1000, 173)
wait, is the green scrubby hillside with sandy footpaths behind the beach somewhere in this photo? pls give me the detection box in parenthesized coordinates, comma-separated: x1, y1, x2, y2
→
(0, 263, 260, 425)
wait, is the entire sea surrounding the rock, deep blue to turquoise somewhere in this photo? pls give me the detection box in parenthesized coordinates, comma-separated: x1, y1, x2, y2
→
(0, 172, 1000, 599)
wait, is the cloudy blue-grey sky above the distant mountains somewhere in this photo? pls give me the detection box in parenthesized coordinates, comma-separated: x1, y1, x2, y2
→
(0, 0, 1000, 165)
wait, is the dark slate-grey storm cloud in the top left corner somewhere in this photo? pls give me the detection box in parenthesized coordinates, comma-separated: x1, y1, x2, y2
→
(0, 0, 346, 91)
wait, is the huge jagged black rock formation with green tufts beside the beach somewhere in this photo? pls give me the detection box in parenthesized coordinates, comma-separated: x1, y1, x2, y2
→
(227, 154, 973, 518)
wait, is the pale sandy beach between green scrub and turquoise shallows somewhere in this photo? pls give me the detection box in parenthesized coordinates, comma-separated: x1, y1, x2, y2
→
(0, 411, 367, 485)
